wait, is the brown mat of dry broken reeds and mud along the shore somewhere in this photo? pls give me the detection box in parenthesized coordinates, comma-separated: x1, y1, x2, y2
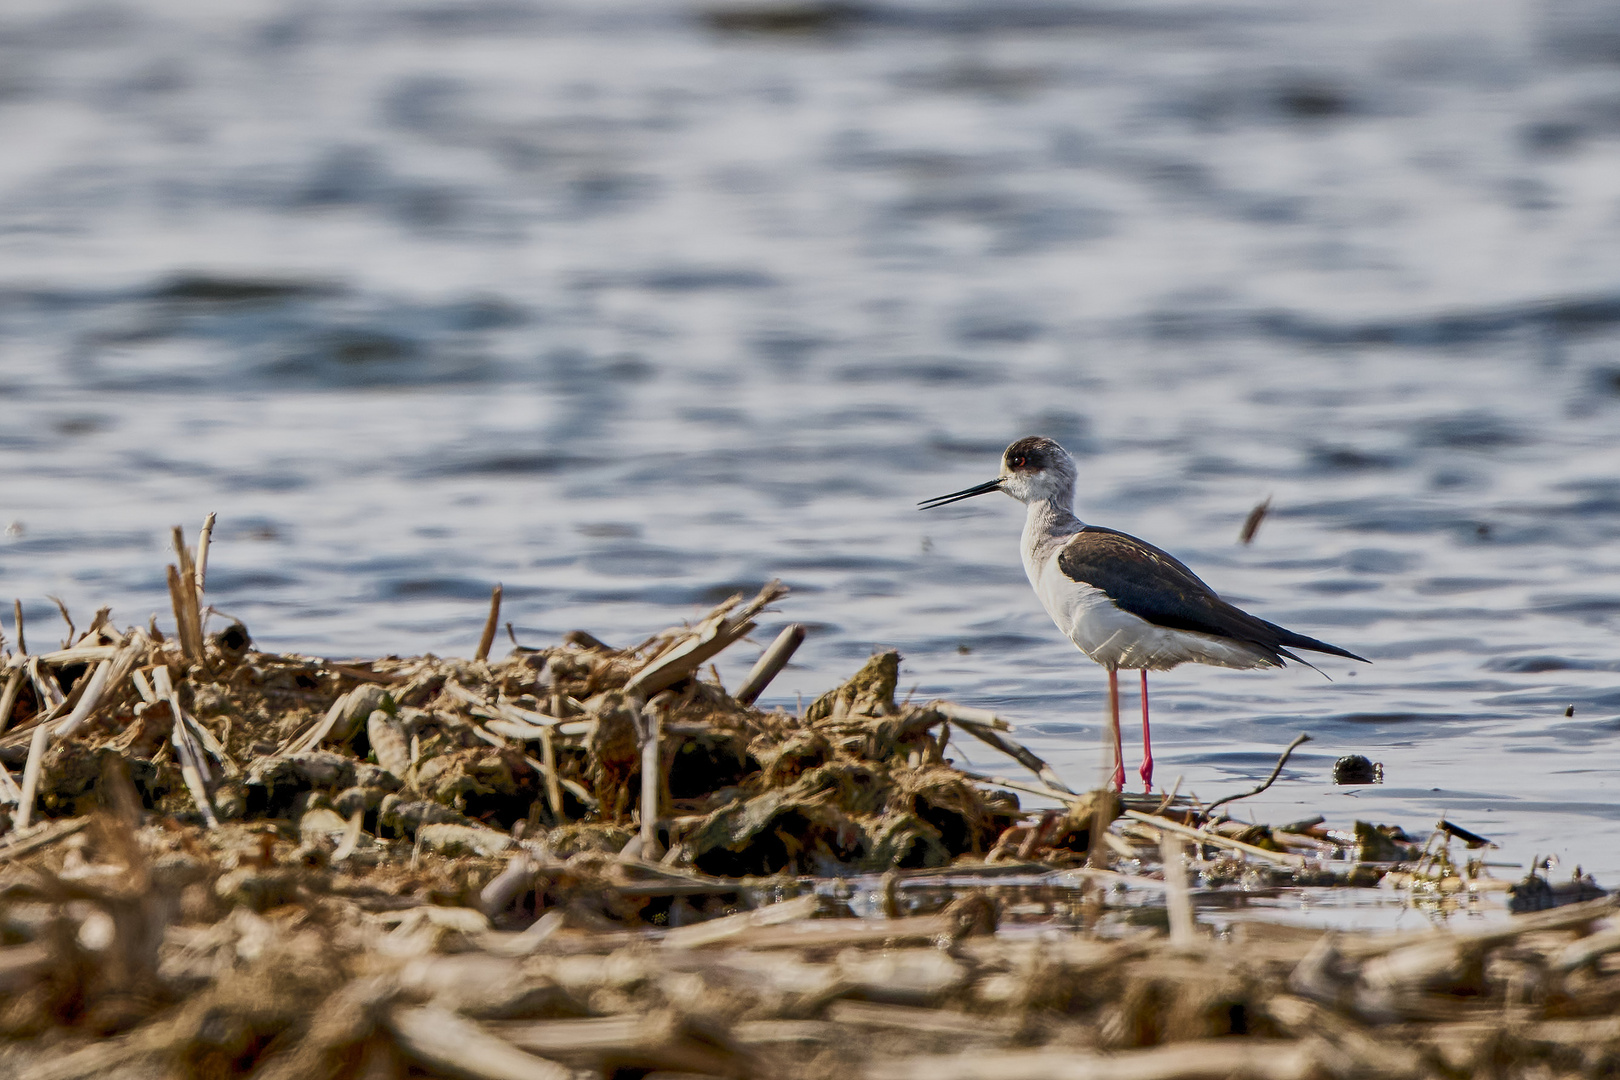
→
(0, 526, 1620, 1080)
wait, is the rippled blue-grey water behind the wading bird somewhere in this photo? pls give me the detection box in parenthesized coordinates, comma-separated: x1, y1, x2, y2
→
(0, 0, 1620, 884)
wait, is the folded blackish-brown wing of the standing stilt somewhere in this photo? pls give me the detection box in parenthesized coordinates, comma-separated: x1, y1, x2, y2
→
(1058, 525, 1362, 661)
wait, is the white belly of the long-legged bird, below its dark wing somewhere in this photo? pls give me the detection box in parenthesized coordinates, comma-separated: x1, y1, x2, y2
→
(1024, 552, 1277, 670)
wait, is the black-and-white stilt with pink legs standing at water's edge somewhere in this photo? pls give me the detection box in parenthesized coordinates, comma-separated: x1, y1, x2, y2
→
(919, 436, 1366, 790)
